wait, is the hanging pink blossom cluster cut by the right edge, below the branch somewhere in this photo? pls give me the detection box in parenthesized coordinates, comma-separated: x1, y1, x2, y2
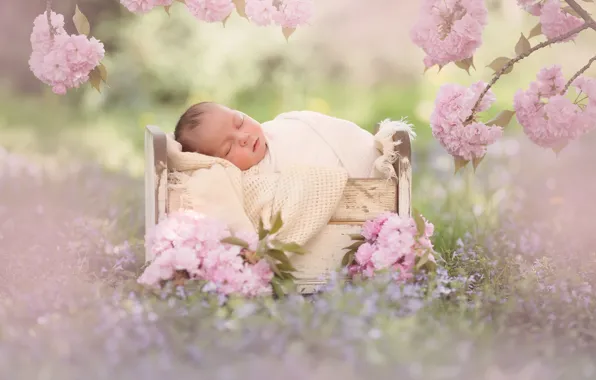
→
(513, 65, 596, 148)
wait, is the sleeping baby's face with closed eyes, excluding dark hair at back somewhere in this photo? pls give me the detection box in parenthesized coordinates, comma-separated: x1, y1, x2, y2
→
(188, 104, 267, 170)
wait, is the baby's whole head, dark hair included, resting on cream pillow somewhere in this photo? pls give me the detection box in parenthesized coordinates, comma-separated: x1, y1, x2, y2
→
(174, 102, 267, 170)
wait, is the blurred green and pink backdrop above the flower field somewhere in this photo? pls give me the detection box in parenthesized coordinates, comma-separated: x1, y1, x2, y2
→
(0, 0, 596, 175)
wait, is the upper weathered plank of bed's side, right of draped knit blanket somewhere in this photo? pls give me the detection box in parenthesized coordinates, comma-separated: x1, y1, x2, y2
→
(330, 178, 397, 223)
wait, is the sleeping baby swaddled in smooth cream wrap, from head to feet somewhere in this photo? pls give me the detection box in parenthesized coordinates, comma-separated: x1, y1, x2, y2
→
(174, 102, 406, 178)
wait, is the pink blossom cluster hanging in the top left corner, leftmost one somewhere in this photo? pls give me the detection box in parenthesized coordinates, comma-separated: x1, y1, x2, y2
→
(29, 12, 105, 95)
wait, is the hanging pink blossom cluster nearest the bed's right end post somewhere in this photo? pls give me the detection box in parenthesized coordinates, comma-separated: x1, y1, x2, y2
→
(430, 82, 503, 161)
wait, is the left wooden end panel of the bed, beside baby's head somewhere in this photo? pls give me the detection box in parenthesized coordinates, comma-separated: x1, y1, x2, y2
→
(145, 125, 168, 262)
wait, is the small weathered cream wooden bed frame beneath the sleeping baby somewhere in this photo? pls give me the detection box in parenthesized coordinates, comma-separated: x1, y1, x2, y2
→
(145, 125, 412, 294)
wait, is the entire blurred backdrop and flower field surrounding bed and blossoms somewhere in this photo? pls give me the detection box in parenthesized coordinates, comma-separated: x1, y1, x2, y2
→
(0, 0, 596, 380)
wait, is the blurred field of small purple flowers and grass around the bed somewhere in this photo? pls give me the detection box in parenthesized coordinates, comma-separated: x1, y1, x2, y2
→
(0, 133, 596, 380)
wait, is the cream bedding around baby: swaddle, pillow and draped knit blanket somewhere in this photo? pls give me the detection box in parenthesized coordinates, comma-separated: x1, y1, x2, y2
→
(168, 111, 414, 244)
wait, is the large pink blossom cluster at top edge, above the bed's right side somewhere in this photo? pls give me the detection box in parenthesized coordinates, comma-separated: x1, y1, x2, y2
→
(410, 0, 488, 68)
